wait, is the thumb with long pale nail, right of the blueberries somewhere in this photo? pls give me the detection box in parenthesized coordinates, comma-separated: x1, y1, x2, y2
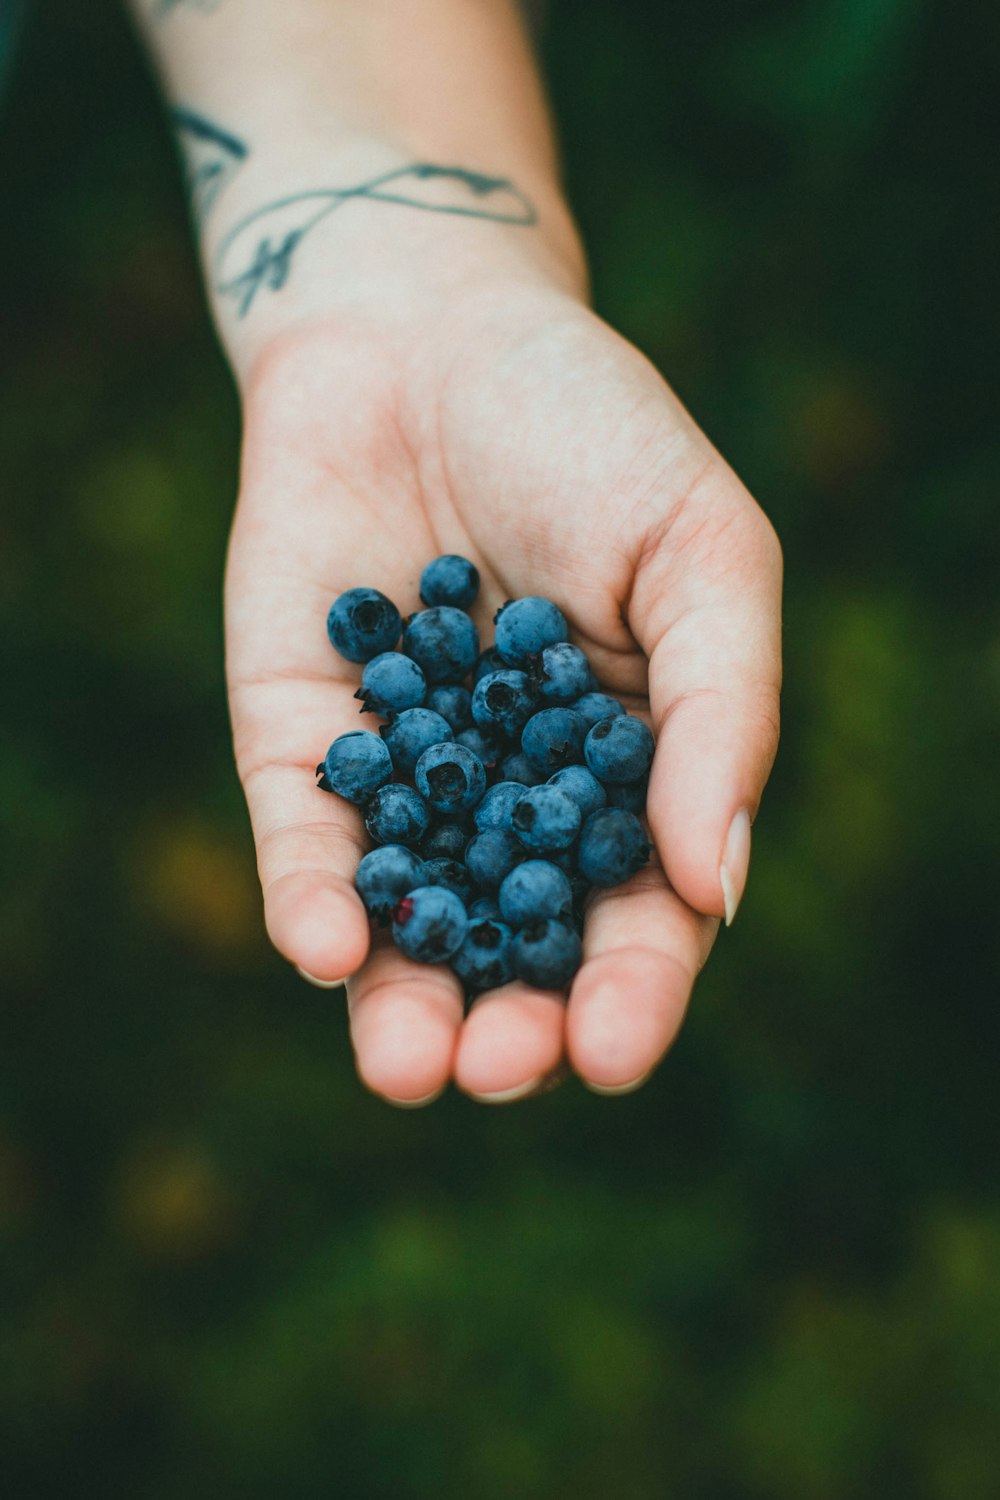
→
(628, 461, 781, 921)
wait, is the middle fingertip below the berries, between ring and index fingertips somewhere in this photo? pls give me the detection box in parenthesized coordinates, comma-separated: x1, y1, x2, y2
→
(454, 984, 565, 1104)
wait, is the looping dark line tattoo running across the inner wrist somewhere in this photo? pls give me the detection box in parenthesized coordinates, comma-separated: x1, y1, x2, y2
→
(216, 162, 538, 318)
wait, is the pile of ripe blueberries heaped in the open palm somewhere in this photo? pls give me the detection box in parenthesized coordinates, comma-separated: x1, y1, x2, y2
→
(316, 555, 654, 995)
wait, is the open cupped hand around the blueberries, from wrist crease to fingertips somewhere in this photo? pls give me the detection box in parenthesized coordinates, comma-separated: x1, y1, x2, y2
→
(226, 282, 781, 1104)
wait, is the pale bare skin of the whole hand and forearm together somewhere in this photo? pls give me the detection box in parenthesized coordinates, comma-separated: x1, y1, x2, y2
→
(131, 0, 781, 1106)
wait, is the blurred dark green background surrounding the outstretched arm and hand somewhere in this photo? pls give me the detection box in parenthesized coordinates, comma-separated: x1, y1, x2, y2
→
(0, 0, 1000, 1500)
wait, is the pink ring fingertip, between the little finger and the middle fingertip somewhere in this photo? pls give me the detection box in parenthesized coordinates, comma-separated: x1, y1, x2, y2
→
(348, 939, 462, 1106)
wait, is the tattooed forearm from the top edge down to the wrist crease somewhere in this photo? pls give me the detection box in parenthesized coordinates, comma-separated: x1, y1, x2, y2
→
(130, 0, 585, 375)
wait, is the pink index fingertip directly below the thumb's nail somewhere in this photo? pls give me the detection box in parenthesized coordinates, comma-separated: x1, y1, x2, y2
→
(567, 866, 718, 1094)
